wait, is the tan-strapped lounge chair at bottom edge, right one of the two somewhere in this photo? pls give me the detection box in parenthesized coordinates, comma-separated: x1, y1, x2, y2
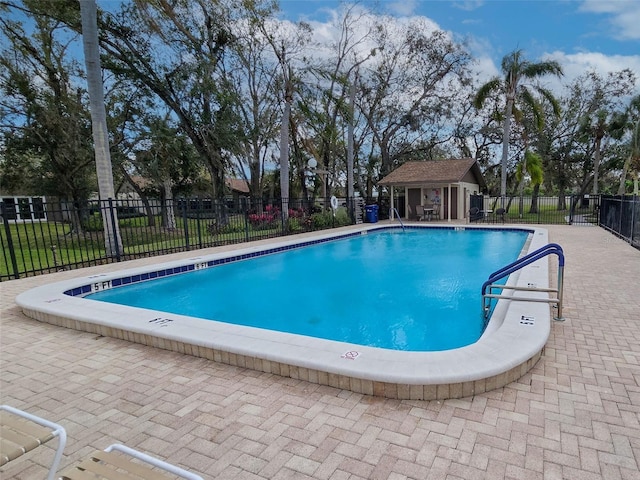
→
(59, 444, 203, 480)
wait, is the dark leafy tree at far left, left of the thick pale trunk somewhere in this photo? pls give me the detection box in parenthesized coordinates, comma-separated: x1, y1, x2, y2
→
(0, 3, 96, 232)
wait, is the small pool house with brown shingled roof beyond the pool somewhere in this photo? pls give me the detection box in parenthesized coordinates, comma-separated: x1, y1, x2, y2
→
(378, 158, 486, 220)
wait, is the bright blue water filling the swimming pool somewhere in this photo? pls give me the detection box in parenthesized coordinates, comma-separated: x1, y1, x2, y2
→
(87, 229, 528, 351)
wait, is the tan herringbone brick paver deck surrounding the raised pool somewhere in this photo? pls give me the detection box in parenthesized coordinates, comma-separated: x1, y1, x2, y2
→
(0, 226, 640, 480)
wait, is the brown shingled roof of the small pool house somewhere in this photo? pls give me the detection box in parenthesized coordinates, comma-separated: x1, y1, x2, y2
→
(378, 158, 486, 188)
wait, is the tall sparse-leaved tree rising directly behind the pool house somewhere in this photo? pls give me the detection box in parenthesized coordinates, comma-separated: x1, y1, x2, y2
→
(357, 18, 470, 180)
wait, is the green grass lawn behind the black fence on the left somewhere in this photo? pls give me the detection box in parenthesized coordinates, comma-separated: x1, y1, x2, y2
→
(0, 214, 344, 279)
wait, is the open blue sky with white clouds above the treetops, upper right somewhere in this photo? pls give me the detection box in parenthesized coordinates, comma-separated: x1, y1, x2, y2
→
(280, 0, 640, 93)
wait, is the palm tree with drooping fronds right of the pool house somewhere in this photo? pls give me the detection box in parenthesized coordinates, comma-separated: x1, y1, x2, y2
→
(473, 50, 563, 203)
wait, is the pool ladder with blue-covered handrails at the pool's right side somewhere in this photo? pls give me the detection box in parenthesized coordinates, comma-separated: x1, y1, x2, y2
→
(482, 243, 564, 321)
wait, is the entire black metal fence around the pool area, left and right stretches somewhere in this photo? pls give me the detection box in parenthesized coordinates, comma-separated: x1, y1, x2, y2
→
(0, 195, 640, 281)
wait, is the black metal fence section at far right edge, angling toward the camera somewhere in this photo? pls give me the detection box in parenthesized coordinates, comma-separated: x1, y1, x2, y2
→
(599, 195, 640, 248)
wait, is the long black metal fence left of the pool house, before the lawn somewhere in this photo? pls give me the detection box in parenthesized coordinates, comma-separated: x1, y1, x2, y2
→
(0, 198, 362, 281)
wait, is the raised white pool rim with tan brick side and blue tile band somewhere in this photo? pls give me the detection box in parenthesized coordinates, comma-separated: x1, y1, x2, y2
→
(16, 224, 551, 400)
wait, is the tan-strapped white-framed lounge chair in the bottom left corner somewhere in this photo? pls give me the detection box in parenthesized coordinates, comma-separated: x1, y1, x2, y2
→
(0, 405, 67, 480)
